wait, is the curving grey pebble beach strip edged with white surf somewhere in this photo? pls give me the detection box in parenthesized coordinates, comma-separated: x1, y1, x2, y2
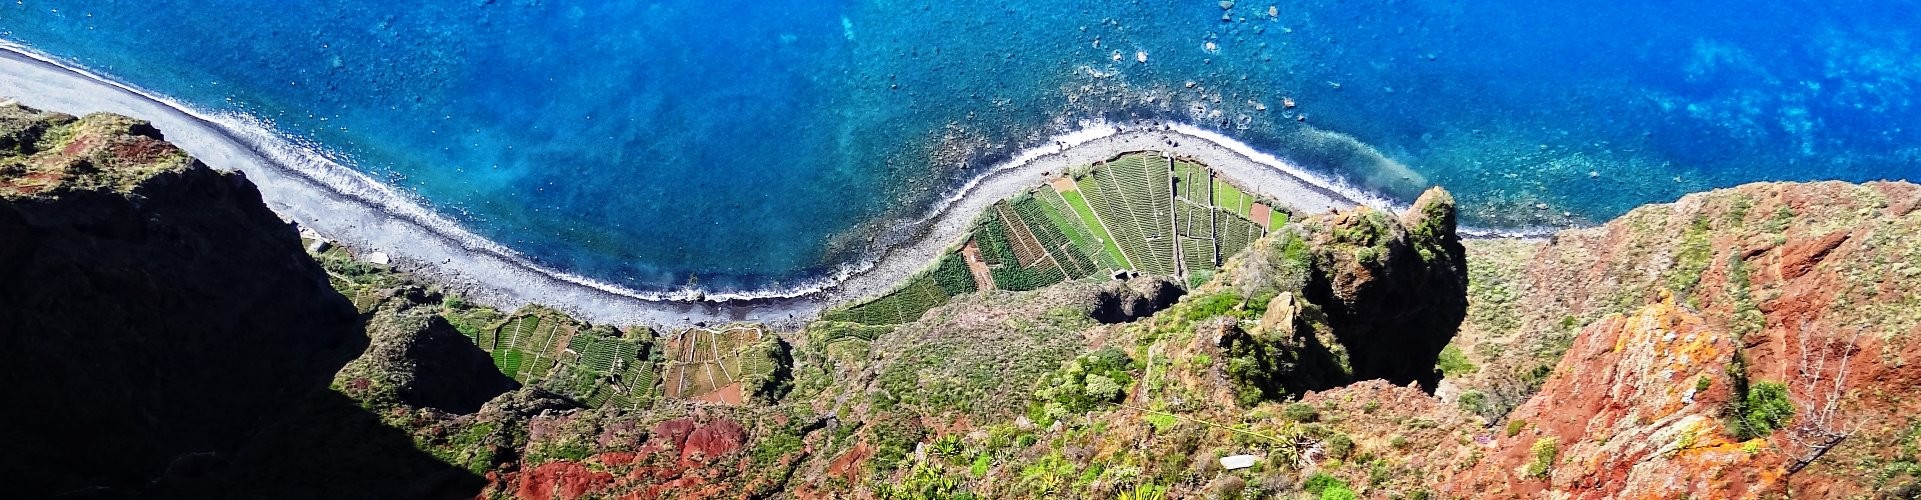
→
(0, 40, 1529, 329)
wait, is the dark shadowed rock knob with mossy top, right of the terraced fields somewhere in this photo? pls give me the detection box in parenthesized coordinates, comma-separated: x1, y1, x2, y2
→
(1197, 188, 1468, 404)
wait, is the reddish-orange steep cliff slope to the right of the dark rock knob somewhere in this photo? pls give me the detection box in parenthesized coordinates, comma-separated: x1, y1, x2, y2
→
(1447, 183, 1921, 498)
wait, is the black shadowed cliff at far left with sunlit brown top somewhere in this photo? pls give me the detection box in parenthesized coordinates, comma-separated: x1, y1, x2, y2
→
(0, 106, 480, 498)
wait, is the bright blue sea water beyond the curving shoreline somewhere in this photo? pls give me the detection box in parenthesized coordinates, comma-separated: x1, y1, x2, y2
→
(0, 0, 1921, 288)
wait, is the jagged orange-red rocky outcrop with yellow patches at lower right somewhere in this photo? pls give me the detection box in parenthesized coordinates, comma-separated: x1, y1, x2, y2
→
(1445, 296, 1787, 498)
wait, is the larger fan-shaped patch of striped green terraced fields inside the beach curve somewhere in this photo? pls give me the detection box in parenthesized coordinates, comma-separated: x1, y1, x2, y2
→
(822, 152, 1287, 325)
